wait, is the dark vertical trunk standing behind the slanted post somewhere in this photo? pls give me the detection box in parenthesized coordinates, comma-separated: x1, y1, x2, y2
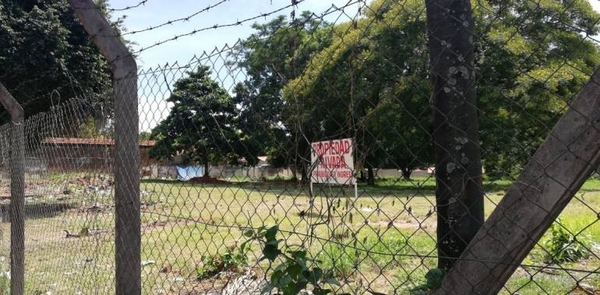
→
(426, 0, 483, 270)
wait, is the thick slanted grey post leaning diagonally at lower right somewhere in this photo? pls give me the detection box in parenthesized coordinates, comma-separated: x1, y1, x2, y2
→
(435, 70, 600, 294)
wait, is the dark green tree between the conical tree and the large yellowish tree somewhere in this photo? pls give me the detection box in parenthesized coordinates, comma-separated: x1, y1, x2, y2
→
(232, 12, 331, 180)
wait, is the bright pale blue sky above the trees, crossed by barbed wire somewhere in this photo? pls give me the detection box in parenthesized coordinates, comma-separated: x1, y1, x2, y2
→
(109, 0, 600, 131)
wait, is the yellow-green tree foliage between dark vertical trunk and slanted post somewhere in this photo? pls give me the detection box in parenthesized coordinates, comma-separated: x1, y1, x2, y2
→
(474, 0, 600, 178)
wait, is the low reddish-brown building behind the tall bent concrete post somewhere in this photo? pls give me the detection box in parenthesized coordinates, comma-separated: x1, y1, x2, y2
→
(36, 137, 156, 172)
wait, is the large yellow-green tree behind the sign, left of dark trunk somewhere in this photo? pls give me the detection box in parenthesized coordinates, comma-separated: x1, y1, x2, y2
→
(284, 1, 432, 184)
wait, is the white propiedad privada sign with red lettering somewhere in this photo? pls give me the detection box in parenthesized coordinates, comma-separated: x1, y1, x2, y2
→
(310, 138, 356, 184)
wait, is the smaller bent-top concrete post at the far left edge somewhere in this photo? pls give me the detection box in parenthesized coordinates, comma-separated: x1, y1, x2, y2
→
(0, 83, 25, 295)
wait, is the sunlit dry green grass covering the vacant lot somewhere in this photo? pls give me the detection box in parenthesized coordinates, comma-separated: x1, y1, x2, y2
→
(0, 175, 600, 294)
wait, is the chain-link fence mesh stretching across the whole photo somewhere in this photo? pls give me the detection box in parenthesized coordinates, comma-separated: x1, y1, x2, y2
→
(0, 0, 600, 294)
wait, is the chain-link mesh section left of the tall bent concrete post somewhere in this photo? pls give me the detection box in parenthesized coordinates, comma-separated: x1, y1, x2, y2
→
(0, 99, 114, 294)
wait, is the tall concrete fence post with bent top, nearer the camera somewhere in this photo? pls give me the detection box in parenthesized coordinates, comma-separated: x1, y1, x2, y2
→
(69, 0, 141, 295)
